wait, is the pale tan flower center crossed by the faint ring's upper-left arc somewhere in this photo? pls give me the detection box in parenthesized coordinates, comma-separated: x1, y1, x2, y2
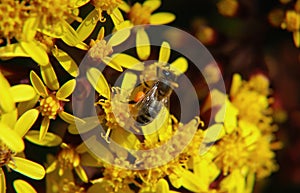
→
(89, 40, 113, 62)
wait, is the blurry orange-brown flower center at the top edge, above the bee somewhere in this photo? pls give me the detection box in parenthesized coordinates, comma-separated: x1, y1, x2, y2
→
(128, 3, 151, 25)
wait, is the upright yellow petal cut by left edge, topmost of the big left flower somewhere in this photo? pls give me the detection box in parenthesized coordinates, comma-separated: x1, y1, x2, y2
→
(0, 72, 15, 113)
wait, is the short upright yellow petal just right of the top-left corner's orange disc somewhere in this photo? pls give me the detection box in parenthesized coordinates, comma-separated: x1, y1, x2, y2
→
(23, 17, 39, 42)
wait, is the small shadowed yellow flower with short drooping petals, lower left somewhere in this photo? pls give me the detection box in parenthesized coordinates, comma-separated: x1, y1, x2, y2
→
(46, 143, 88, 183)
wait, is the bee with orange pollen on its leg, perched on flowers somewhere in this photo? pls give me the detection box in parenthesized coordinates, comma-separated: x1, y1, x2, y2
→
(132, 68, 178, 126)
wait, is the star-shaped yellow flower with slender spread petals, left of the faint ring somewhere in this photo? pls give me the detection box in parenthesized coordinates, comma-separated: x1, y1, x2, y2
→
(30, 71, 80, 140)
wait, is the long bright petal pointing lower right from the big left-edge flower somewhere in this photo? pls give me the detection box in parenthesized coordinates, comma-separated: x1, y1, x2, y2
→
(8, 157, 45, 180)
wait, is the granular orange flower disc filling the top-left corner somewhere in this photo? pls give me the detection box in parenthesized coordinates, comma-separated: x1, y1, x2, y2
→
(0, 0, 29, 43)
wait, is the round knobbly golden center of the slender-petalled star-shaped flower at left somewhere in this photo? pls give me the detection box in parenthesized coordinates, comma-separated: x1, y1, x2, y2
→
(40, 95, 62, 119)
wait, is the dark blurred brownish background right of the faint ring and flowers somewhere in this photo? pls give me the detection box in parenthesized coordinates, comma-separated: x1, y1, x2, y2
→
(160, 0, 300, 193)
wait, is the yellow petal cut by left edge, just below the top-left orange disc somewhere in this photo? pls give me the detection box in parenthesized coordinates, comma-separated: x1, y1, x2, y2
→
(0, 43, 30, 58)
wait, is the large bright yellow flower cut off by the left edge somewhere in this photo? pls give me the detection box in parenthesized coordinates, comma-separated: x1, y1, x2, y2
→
(0, 72, 45, 192)
